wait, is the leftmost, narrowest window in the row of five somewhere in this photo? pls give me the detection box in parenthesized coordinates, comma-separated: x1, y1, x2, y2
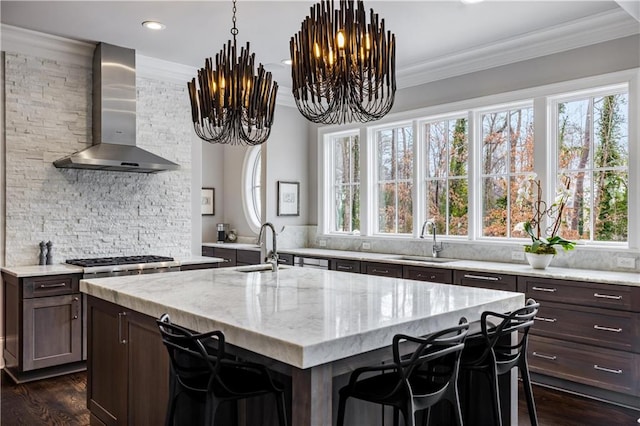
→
(330, 134, 360, 233)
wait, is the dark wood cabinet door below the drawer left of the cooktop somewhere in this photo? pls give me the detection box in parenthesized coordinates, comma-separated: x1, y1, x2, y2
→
(22, 293, 82, 371)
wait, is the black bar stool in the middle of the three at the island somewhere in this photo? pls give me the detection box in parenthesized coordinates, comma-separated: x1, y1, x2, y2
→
(338, 318, 469, 426)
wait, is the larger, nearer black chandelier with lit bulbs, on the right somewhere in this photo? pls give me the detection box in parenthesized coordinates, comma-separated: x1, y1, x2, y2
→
(290, 0, 396, 124)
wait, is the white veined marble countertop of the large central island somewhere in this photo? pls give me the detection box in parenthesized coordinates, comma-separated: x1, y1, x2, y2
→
(80, 267, 524, 369)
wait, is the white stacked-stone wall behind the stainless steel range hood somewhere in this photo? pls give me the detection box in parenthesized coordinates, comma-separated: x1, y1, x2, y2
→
(4, 52, 195, 266)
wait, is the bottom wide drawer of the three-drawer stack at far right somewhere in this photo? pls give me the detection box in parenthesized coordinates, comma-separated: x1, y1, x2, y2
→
(527, 336, 640, 395)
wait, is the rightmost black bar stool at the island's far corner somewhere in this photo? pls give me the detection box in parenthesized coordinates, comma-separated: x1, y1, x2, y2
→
(460, 299, 540, 426)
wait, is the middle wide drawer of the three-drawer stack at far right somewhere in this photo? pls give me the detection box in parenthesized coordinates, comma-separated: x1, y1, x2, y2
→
(531, 302, 640, 352)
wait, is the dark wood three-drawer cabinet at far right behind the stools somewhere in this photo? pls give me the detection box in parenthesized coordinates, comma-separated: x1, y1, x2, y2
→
(518, 276, 640, 405)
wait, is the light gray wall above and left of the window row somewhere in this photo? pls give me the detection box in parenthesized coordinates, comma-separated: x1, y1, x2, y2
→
(308, 35, 640, 224)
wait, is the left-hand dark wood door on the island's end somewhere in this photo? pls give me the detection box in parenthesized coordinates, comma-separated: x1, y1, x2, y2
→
(87, 296, 128, 426)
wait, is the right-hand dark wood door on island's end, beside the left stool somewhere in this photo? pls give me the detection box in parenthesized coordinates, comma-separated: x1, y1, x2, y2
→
(126, 311, 169, 425)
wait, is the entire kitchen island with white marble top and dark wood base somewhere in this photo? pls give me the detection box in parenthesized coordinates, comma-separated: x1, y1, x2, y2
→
(80, 267, 524, 426)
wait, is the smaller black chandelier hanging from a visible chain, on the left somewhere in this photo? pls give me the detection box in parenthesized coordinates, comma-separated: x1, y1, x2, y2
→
(187, 0, 278, 145)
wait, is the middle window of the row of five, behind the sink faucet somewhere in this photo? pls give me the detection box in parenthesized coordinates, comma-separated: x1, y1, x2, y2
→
(423, 117, 469, 235)
